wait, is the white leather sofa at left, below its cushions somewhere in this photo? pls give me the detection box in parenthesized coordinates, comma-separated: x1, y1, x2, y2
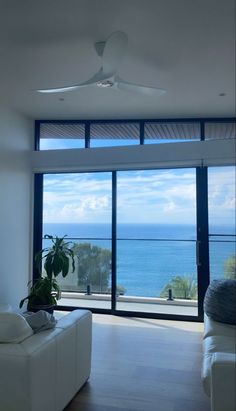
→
(0, 310, 92, 411)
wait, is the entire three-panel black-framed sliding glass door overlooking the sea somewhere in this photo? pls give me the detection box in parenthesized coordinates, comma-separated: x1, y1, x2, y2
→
(35, 167, 235, 319)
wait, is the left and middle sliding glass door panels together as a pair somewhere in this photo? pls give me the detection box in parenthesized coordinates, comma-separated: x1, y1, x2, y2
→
(39, 169, 198, 317)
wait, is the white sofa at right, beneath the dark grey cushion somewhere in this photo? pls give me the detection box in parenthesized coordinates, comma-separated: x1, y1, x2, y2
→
(202, 314, 236, 411)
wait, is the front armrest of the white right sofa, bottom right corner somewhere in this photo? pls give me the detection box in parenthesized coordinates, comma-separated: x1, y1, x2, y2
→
(211, 352, 236, 411)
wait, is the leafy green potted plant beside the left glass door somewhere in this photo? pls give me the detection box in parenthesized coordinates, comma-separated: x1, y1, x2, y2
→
(19, 234, 75, 313)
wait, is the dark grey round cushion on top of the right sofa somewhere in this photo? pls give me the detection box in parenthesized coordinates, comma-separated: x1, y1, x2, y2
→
(204, 280, 236, 324)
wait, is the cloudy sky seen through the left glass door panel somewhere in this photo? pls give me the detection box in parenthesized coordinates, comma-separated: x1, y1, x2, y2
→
(44, 174, 111, 223)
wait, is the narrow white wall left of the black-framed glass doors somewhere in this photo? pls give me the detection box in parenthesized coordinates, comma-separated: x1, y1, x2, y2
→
(0, 109, 33, 306)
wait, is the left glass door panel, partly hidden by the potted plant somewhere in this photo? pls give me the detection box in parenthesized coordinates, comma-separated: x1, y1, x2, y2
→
(43, 173, 111, 309)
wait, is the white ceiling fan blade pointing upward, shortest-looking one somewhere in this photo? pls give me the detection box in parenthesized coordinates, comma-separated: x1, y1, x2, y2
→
(102, 31, 128, 74)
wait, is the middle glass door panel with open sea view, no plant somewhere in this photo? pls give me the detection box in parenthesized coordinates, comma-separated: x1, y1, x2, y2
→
(116, 169, 198, 316)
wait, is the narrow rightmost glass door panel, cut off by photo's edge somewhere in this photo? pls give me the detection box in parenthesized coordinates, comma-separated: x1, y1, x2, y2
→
(208, 167, 236, 280)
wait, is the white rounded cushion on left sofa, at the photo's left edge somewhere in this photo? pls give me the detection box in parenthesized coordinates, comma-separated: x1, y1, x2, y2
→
(0, 312, 33, 343)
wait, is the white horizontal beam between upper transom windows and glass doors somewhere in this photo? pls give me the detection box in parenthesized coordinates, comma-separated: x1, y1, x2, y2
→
(32, 140, 235, 172)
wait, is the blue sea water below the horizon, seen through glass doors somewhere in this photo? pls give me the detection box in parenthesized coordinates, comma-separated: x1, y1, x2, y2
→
(43, 223, 235, 297)
